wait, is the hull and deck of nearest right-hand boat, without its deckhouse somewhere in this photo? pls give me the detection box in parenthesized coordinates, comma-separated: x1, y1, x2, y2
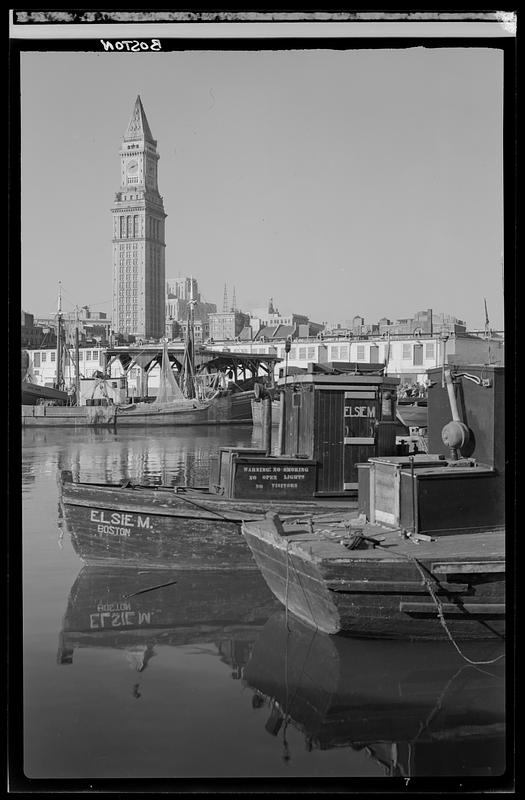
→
(242, 519, 505, 640)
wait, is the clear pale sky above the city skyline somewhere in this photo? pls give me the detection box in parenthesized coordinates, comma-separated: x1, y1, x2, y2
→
(21, 46, 503, 328)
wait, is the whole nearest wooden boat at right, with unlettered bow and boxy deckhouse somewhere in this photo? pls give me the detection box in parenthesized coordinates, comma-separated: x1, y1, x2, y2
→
(242, 366, 505, 639)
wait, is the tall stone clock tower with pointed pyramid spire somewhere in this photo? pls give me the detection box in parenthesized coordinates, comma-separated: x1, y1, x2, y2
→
(111, 95, 166, 339)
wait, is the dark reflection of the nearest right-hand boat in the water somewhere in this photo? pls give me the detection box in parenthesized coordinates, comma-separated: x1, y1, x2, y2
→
(243, 611, 505, 777)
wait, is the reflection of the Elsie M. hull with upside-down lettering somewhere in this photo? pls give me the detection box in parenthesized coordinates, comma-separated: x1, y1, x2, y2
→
(57, 567, 278, 679)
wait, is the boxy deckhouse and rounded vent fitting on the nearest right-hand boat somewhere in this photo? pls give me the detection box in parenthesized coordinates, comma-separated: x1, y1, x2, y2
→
(358, 365, 505, 536)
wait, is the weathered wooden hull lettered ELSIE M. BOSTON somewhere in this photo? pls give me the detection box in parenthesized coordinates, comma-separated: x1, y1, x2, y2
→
(60, 471, 355, 570)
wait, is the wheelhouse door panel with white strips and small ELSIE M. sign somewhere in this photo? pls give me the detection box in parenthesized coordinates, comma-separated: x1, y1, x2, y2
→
(343, 390, 379, 491)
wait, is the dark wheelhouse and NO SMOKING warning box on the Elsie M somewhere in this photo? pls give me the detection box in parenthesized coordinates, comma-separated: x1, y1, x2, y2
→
(210, 365, 399, 499)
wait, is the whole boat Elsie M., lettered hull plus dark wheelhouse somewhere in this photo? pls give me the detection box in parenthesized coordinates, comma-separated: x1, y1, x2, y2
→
(58, 370, 404, 569)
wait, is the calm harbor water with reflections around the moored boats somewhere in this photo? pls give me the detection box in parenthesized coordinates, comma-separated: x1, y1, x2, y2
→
(22, 427, 505, 779)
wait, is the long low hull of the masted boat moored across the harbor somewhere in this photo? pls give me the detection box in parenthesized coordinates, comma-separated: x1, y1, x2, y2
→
(22, 391, 253, 428)
